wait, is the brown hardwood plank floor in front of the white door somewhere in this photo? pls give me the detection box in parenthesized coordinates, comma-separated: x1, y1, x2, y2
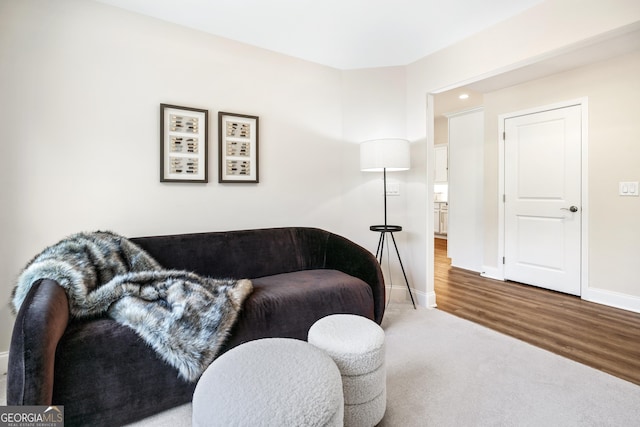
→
(435, 239, 640, 385)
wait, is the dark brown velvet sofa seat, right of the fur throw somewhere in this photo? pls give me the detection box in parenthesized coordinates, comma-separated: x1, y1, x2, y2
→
(223, 269, 374, 351)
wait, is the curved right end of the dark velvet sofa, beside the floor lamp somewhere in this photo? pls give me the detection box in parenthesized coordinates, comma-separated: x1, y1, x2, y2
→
(325, 233, 385, 324)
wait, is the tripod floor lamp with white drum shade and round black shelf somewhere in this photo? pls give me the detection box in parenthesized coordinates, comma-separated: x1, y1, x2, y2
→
(360, 138, 416, 308)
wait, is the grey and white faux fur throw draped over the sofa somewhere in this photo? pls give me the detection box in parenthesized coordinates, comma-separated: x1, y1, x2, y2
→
(11, 232, 253, 381)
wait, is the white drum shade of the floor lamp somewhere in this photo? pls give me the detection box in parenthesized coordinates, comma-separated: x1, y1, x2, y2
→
(360, 138, 411, 172)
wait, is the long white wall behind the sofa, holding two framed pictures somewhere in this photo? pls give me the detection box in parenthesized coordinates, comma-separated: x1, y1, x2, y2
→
(0, 0, 388, 354)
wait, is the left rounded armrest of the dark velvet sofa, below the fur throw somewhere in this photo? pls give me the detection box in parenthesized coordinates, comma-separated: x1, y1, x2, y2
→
(7, 279, 69, 405)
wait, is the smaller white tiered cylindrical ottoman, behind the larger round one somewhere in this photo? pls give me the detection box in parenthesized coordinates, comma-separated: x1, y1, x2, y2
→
(308, 314, 387, 427)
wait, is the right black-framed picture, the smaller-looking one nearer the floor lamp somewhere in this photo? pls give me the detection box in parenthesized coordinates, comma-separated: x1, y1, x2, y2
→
(218, 111, 259, 183)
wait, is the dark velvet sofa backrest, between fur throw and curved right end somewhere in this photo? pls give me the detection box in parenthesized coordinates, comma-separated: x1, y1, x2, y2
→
(131, 227, 330, 278)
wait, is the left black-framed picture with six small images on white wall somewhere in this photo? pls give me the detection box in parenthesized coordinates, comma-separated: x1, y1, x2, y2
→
(160, 104, 209, 182)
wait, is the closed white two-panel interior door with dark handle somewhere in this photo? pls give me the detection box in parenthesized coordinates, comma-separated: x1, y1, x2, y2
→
(504, 105, 582, 295)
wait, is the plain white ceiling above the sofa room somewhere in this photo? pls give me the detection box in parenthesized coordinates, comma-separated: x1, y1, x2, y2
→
(98, 0, 543, 70)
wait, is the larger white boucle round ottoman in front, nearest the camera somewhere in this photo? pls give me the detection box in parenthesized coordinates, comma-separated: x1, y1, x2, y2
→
(192, 338, 344, 427)
